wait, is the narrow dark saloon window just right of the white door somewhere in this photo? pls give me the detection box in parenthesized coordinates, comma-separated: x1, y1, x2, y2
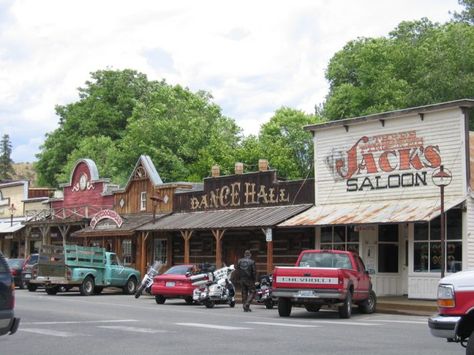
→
(378, 224, 398, 273)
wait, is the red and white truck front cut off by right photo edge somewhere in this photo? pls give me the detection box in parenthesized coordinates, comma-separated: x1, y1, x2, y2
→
(428, 270, 474, 355)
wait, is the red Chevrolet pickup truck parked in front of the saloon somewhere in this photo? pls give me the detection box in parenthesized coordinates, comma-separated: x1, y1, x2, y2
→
(272, 250, 376, 318)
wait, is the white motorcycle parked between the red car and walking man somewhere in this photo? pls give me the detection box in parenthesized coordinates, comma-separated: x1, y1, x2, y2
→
(190, 265, 235, 308)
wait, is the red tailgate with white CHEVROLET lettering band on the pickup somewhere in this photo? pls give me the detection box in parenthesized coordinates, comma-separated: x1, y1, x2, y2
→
(273, 267, 342, 289)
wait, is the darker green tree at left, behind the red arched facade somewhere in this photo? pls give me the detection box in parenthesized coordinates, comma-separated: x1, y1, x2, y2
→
(36, 69, 160, 186)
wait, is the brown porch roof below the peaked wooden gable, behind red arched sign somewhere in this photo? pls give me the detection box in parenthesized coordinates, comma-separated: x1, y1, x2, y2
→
(73, 213, 166, 237)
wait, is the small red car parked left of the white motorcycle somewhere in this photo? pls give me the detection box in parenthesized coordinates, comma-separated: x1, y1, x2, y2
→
(151, 264, 196, 304)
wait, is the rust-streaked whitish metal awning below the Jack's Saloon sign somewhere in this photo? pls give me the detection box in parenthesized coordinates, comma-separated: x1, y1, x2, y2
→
(278, 197, 466, 227)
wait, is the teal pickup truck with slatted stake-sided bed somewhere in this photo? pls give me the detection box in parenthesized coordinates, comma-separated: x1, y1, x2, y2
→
(30, 245, 140, 296)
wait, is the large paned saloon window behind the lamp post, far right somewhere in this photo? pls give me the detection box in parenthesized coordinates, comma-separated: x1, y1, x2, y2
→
(413, 209, 462, 272)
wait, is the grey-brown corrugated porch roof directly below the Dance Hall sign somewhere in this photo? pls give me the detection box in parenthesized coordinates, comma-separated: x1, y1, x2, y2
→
(138, 204, 312, 231)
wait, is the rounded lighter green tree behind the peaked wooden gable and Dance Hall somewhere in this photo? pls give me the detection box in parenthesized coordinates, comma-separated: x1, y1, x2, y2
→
(117, 85, 240, 181)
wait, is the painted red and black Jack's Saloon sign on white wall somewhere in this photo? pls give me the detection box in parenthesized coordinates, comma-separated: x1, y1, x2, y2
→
(332, 131, 442, 192)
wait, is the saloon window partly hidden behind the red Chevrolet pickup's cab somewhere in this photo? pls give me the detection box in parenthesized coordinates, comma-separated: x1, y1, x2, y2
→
(321, 226, 359, 254)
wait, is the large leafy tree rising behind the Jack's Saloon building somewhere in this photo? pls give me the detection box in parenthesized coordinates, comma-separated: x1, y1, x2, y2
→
(323, 19, 474, 126)
